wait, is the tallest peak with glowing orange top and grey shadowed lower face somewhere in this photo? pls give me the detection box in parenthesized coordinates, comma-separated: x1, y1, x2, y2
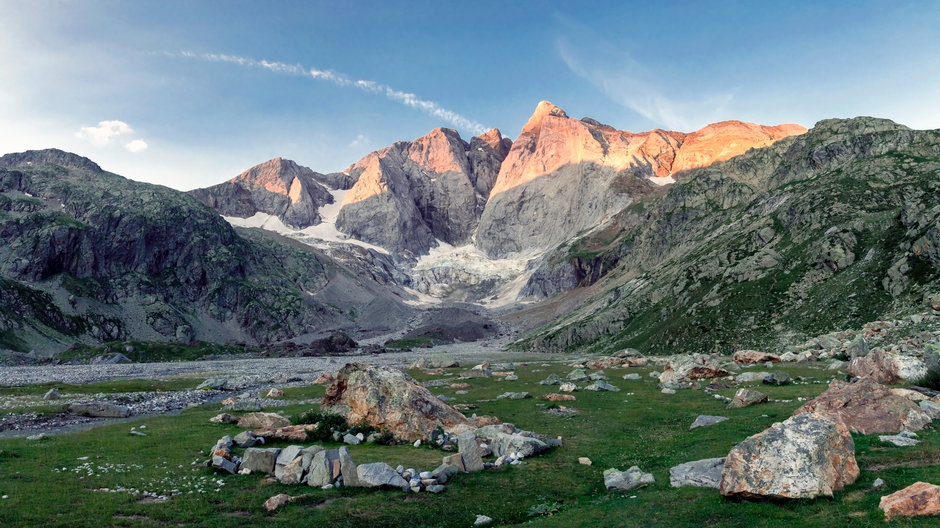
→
(475, 101, 806, 258)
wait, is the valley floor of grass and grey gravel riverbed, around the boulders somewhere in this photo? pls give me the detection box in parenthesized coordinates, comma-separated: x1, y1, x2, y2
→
(0, 347, 940, 528)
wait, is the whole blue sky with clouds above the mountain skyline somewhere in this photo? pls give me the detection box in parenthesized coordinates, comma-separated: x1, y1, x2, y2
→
(0, 0, 940, 190)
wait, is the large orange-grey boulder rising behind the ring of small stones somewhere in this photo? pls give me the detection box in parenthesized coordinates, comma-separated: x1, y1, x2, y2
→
(321, 363, 470, 442)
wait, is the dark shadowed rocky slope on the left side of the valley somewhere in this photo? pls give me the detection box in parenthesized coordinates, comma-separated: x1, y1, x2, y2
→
(0, 150, 408, 352)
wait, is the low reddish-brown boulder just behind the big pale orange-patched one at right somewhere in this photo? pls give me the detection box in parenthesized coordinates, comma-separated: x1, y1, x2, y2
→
(793, 379, 931, 434)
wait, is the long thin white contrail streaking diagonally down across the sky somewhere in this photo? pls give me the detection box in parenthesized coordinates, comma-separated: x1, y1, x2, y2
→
(167, 51, 487, 135)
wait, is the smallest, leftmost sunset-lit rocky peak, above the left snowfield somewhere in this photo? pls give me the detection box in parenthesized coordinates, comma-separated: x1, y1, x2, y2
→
(190, 158, 333, 229)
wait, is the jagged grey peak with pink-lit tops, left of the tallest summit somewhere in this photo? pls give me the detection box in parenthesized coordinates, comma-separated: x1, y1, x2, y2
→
(336, 128, 510, 255)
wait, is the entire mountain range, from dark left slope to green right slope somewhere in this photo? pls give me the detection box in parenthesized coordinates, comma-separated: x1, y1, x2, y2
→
(0, 101, 940, 355)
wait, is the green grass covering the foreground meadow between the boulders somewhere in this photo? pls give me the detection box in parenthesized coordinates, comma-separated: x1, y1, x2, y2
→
(0, 362, 940, 528)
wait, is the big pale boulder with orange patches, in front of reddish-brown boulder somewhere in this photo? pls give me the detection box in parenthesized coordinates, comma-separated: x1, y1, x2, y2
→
(719, 413, 859, 499)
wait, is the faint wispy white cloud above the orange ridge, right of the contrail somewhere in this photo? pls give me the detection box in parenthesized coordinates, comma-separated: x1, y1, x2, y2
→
(556, 37, 735, 131)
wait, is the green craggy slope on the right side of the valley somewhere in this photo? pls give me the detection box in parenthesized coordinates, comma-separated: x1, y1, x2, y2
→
(520, 118, 940, 353)
